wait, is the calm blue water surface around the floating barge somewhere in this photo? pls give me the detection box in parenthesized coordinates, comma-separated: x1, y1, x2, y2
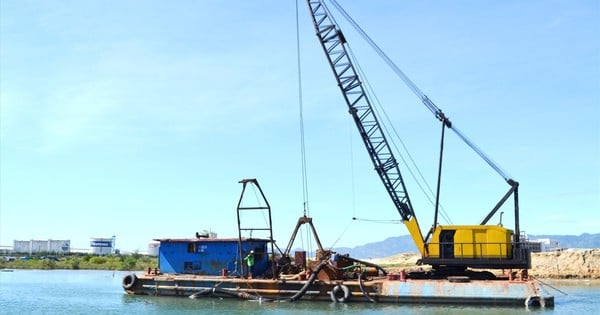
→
(0, 270, 600, 315)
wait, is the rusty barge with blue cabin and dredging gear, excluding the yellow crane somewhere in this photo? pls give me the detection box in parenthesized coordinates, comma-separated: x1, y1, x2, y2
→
(122, 179, 554, 307)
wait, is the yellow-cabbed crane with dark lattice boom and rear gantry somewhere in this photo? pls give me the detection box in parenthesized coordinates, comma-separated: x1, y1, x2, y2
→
(307, 0, 531, 270)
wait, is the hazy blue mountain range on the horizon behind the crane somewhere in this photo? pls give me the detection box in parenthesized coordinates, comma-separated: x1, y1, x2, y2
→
(333, 233, 600, 259)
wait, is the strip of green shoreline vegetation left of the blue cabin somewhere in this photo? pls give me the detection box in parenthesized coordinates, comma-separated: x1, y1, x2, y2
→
(0, 254, 158, 271)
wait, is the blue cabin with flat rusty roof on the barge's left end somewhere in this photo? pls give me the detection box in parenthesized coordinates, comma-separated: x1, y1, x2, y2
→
(155, 238, 270, 277)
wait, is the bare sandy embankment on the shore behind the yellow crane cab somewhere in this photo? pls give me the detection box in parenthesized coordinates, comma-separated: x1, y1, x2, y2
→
(370, 249, 600, 279)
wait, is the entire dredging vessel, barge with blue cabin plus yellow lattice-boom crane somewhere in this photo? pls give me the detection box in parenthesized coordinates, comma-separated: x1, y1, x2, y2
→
(123, 0, 554, 307)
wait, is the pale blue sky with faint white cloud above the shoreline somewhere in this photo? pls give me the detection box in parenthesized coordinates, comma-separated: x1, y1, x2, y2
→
(0, 0, 600, 251)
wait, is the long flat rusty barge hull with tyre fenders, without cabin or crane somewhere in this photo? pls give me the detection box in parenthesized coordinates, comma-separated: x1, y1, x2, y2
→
(123, 263, 554, 307)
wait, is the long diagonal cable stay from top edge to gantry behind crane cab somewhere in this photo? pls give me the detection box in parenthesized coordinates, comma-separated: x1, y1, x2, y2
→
(330, 0, 512, 185)
